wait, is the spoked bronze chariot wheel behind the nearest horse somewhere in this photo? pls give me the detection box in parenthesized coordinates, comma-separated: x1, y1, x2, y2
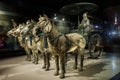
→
(88, 34, 103, 59)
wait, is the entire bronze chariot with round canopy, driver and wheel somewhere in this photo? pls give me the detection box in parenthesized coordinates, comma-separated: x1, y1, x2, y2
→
(60, 2, 103, 58)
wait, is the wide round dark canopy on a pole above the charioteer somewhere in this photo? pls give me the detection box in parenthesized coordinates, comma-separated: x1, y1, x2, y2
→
(60, 2, 99, 25)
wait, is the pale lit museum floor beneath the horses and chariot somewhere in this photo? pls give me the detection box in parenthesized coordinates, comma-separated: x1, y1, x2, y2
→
(0, 53, 120, 80)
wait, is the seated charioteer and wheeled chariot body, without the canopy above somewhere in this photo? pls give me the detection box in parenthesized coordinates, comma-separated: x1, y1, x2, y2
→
(71, 12, 103, 58)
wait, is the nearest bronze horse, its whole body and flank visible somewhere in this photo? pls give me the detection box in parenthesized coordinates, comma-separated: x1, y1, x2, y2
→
(37, 15, 86, 78)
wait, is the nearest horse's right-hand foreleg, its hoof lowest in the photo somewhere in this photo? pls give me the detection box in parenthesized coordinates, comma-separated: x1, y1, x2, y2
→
(60, 55, 66, 79)
